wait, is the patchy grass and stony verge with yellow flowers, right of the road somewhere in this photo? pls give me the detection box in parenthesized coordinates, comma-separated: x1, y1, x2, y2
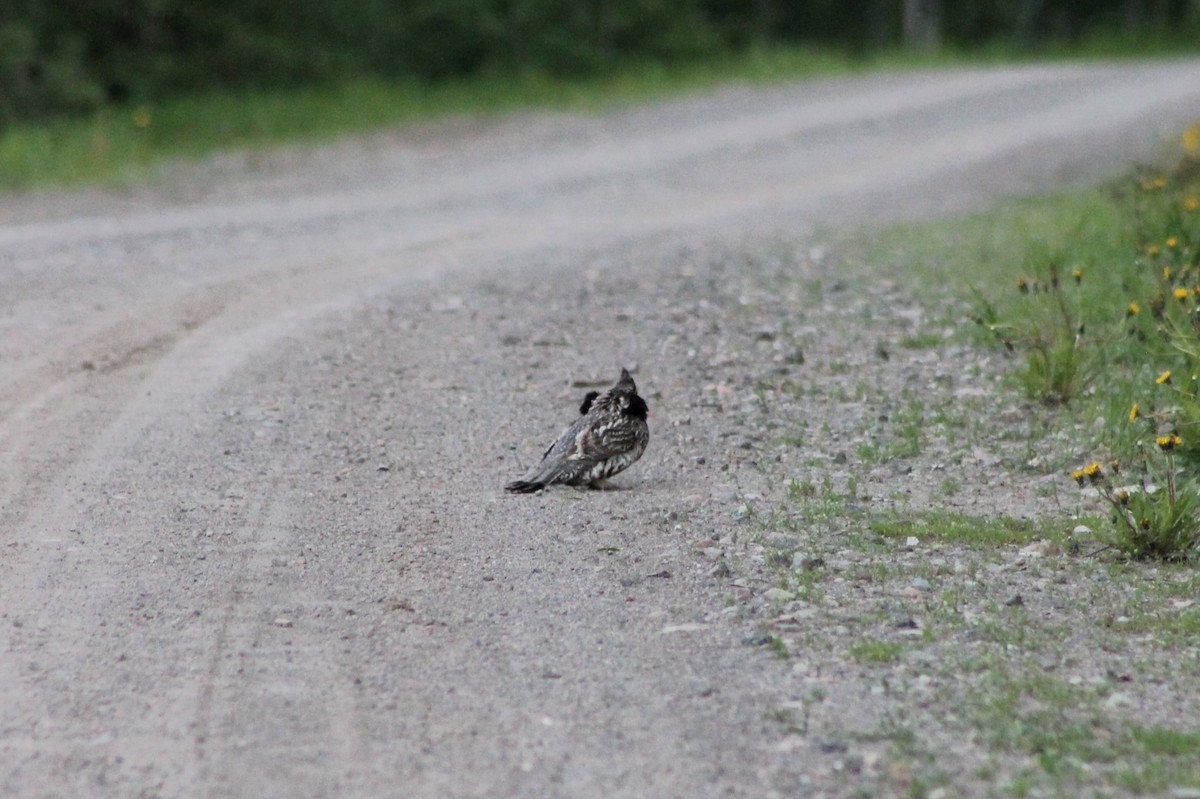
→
(756, 141, 1200, 797)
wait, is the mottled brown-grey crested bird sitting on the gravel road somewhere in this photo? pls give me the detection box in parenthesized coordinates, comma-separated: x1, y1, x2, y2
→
(505, 370, 650, 493)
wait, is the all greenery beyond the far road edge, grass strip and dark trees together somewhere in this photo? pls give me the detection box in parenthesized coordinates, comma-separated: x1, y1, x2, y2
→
(7, 0, 1200, 191)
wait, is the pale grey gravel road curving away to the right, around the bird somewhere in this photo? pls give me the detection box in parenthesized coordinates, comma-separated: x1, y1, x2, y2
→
(7, 61, 1200, 799)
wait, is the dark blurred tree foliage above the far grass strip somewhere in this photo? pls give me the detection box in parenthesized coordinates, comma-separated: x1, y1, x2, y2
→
(0, 0, 1200, 126)
